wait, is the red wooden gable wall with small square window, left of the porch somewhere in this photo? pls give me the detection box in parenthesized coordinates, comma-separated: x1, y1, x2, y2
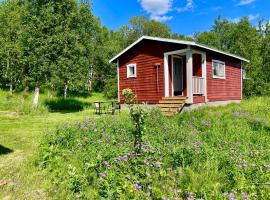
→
(119, 40, 186, 103)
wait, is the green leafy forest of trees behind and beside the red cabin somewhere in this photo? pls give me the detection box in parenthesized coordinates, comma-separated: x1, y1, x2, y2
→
(0, 0, 270, 104)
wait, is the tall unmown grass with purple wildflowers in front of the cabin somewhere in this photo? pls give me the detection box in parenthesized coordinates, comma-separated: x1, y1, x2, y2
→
(37, 98, 270, 199)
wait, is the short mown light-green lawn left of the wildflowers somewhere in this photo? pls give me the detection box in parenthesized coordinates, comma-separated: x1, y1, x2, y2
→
(0, 91, 110, 199)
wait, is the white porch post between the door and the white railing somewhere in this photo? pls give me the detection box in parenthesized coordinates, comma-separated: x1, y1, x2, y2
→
(186, 47, 193, 104)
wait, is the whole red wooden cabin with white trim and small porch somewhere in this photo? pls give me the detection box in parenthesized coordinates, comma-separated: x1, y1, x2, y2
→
(110, 36, 249, 112)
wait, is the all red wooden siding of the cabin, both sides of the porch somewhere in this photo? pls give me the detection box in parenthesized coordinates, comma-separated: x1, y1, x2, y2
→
(119, 40, 241, 103)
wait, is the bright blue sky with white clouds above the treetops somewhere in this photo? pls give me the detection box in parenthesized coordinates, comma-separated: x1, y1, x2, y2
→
(92, 0, 270, 36)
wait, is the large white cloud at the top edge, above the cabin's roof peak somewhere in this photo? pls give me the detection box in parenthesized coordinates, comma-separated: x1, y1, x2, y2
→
(138, 0, 173, 22)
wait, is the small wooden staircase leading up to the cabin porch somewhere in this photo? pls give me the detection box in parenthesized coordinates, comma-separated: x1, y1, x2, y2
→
(158, 96, 187, 116)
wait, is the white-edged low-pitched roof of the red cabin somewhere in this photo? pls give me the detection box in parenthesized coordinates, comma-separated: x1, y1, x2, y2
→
(110, 36, 249, 63)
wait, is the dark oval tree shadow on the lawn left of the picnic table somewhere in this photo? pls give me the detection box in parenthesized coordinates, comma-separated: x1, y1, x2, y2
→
(44, 98, 91, 113)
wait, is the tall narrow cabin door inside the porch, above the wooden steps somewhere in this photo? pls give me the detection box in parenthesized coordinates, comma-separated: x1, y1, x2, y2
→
(172, 57, 183, 96)
